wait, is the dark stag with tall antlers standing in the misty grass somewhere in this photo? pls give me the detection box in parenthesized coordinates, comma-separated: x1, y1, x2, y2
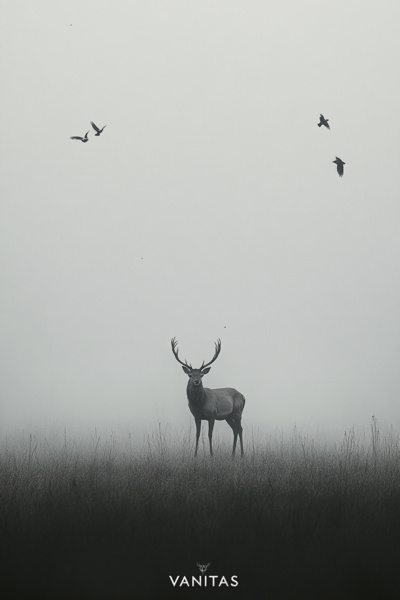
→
(171, 338, 246, 457)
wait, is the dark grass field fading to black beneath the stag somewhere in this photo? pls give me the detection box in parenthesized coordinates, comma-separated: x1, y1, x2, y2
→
(0, 420, 400, 600)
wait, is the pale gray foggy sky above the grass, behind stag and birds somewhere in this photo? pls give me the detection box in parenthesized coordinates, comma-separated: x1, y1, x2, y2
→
(0, 0, 400, 435)
